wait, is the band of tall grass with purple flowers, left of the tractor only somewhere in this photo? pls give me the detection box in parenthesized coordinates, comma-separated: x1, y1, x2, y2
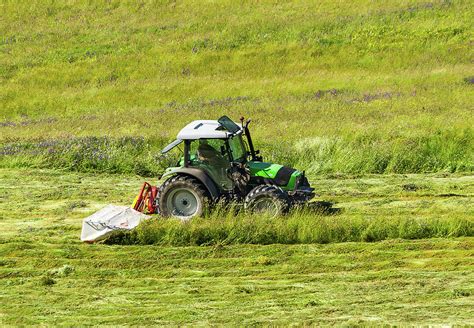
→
(0, 137, 168, 176)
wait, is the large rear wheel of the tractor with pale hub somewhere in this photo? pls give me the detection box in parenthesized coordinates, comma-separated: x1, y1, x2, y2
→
(158, 175, 210, 220)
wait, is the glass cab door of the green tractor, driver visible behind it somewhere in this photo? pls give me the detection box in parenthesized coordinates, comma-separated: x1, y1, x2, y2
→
(189, 139, 233, 190)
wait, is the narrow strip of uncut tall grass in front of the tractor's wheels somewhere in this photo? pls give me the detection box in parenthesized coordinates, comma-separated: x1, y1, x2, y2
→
(106, 211, 474, 246)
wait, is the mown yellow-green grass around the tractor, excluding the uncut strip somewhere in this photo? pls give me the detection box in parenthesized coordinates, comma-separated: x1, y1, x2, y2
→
(0, 169, 474, 325)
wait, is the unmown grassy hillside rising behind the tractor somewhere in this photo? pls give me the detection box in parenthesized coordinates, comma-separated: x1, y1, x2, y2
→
(0, 0, 474, 173)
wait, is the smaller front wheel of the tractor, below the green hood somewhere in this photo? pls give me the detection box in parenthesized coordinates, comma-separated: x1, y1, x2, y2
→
(244, 185, 290, 217)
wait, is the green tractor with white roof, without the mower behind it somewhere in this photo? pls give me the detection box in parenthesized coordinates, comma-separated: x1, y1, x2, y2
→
(155, 116, 314, 219)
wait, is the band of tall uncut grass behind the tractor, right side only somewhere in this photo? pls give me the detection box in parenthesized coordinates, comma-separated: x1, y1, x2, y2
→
(280, 128, 474, 174)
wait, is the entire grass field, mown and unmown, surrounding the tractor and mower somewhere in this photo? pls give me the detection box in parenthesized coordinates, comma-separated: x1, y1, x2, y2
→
(0, 0, 474, 326)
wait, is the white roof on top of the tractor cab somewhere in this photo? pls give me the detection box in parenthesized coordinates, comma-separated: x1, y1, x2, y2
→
(177, 120, 242, 140)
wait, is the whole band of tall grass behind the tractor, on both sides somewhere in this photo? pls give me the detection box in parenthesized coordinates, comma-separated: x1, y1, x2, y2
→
(0, 129, 474, 176)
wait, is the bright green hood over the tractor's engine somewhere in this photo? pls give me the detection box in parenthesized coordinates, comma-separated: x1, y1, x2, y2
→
(247, 161, 302, 190)
